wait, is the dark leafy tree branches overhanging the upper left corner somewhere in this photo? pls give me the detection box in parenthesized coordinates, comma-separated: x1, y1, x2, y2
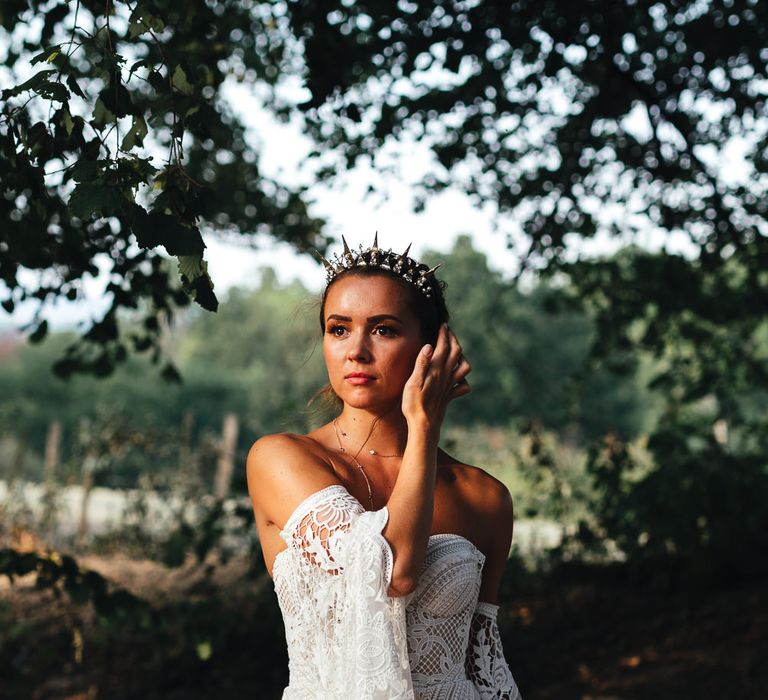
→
(0, 0, 325, 378)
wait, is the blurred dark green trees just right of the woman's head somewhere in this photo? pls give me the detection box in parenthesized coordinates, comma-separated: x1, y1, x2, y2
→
(425, 236, 653, 441)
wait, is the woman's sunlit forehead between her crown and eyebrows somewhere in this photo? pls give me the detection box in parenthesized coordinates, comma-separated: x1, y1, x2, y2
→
(324, 275, 415, 320)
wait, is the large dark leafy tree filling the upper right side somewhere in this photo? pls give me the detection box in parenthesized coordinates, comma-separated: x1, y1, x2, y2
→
(282, 0, 768, 572)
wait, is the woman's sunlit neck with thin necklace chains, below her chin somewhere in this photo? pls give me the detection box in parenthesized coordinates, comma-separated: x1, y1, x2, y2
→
(336, 404, 408, 456)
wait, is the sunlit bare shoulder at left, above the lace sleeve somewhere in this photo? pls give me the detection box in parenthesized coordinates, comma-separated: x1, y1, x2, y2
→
(246, 433, 339, 526)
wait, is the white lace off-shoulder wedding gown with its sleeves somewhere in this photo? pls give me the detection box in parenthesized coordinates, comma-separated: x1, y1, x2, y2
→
(272, 485, 520, 700)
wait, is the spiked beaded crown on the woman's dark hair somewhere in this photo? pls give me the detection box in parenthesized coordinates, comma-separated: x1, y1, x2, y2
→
(318, 233, 440, 299)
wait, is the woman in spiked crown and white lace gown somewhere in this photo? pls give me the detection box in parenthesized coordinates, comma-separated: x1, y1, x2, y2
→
(247, 238, 519, 700)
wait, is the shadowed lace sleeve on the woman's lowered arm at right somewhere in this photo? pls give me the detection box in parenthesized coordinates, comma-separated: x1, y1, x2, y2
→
(466, 602, 520, 700)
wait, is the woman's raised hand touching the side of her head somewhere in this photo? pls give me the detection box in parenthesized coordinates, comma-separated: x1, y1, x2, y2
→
(402, 324, 472, 434)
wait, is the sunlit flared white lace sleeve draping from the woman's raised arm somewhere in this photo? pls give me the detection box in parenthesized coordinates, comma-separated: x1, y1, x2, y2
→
(279, 486, 413, 700)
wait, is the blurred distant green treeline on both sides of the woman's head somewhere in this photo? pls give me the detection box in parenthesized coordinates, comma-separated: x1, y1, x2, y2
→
(0, 237, 656, 486)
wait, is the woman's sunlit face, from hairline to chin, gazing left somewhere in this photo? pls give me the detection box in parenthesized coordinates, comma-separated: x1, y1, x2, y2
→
(323, 275, 424, 410)
